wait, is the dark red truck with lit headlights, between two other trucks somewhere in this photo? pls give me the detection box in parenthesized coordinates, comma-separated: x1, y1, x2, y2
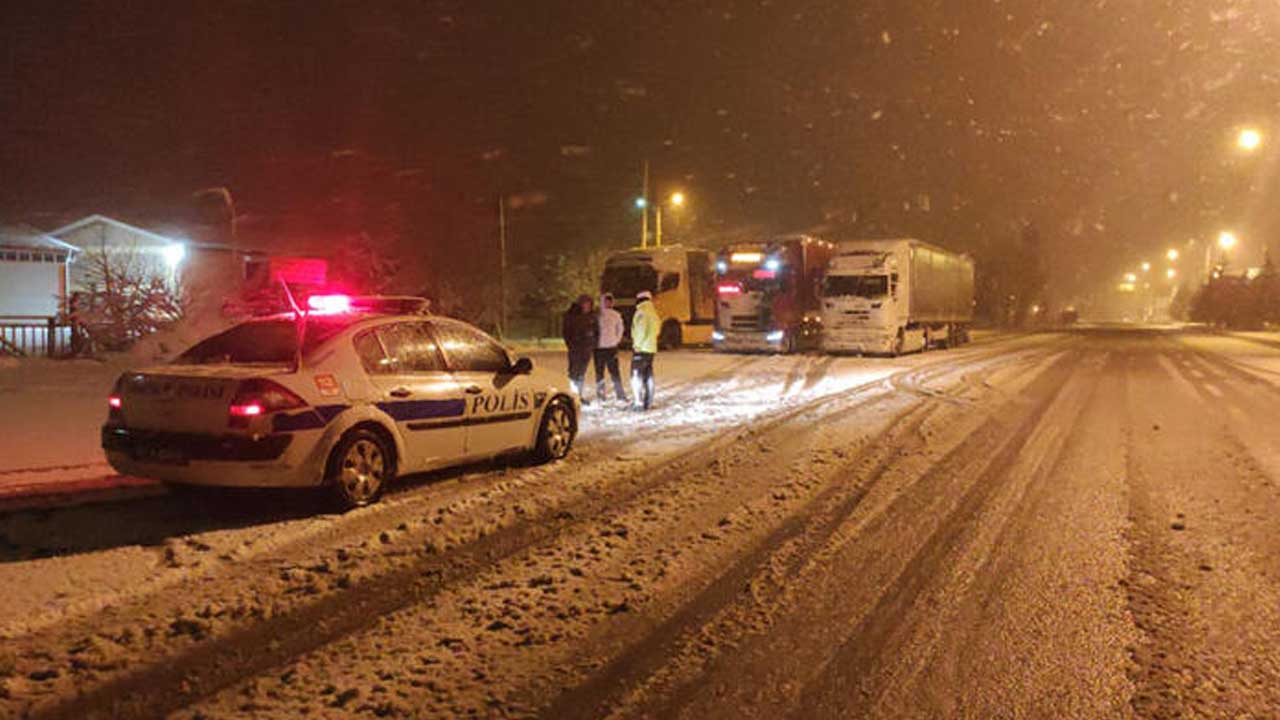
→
(712, 234, 835, 352)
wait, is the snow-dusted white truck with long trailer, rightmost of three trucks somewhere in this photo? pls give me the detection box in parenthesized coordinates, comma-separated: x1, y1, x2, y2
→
(822, 238, 974, 355)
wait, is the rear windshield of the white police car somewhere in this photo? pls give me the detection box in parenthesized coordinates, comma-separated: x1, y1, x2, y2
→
(174, 316, 357, 365)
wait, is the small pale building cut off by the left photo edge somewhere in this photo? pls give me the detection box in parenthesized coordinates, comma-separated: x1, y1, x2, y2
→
(0, 225, 79, 313)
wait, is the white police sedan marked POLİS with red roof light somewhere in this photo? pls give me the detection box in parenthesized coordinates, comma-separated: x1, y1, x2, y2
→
(102, 296, 580, 509)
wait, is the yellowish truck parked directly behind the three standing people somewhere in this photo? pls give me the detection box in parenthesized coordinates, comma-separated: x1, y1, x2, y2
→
(600, 245, 716, 348)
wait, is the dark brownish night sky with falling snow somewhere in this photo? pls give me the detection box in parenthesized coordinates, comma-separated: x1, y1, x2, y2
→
(0, 0, 1280, 297)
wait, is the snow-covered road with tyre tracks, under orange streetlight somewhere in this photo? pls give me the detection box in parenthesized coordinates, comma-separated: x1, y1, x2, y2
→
(0, 329, 1280, 719)
